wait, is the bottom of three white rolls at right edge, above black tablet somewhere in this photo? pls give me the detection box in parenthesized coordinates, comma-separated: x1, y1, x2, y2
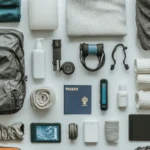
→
(136, 91, 150, 109)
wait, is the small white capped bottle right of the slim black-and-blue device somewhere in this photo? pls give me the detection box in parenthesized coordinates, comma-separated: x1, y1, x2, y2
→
(118, 85, 128, 108)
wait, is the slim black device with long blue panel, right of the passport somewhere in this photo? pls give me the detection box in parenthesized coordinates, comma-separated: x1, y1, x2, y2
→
(100, 79, 108, 111)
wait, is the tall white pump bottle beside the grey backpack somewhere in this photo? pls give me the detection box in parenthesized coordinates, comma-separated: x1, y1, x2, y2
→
(33, 38, 46, 79)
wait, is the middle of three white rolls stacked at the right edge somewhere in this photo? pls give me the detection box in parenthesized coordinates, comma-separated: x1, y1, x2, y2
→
(136, 74, 150, 84)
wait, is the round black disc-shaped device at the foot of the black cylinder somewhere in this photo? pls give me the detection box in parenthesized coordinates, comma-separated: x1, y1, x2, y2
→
(60, 62, 75, 75)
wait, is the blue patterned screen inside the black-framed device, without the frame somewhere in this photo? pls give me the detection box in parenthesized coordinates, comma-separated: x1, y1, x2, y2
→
(36, 126, 59, 141)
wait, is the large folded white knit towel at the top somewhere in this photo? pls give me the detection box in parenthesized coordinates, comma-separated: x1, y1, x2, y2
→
(67, 0, 126, 36)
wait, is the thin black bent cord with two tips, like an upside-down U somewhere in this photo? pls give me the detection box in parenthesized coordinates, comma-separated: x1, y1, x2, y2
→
(110, 44, 129, 70)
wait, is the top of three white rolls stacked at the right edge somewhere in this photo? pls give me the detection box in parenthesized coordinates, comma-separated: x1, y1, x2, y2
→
(135, 59, 150, 74)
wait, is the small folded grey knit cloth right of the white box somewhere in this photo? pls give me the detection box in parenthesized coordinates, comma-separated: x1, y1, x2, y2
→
(105, 121, 119, 142)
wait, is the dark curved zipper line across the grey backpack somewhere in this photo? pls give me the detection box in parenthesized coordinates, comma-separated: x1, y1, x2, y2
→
(0, 46, 24, 82)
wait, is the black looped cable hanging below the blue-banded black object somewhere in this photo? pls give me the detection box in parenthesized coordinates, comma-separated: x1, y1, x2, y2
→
(80, 47, 106, 72)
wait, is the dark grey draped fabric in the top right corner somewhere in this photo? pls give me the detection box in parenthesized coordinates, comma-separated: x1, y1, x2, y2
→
(136, 0, 150, 50)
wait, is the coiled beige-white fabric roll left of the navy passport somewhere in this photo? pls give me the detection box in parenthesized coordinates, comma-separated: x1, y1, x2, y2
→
(30, 87, 56, 110)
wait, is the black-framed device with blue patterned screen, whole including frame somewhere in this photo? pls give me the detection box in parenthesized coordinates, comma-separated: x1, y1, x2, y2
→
(31, 123, 61, 143)
